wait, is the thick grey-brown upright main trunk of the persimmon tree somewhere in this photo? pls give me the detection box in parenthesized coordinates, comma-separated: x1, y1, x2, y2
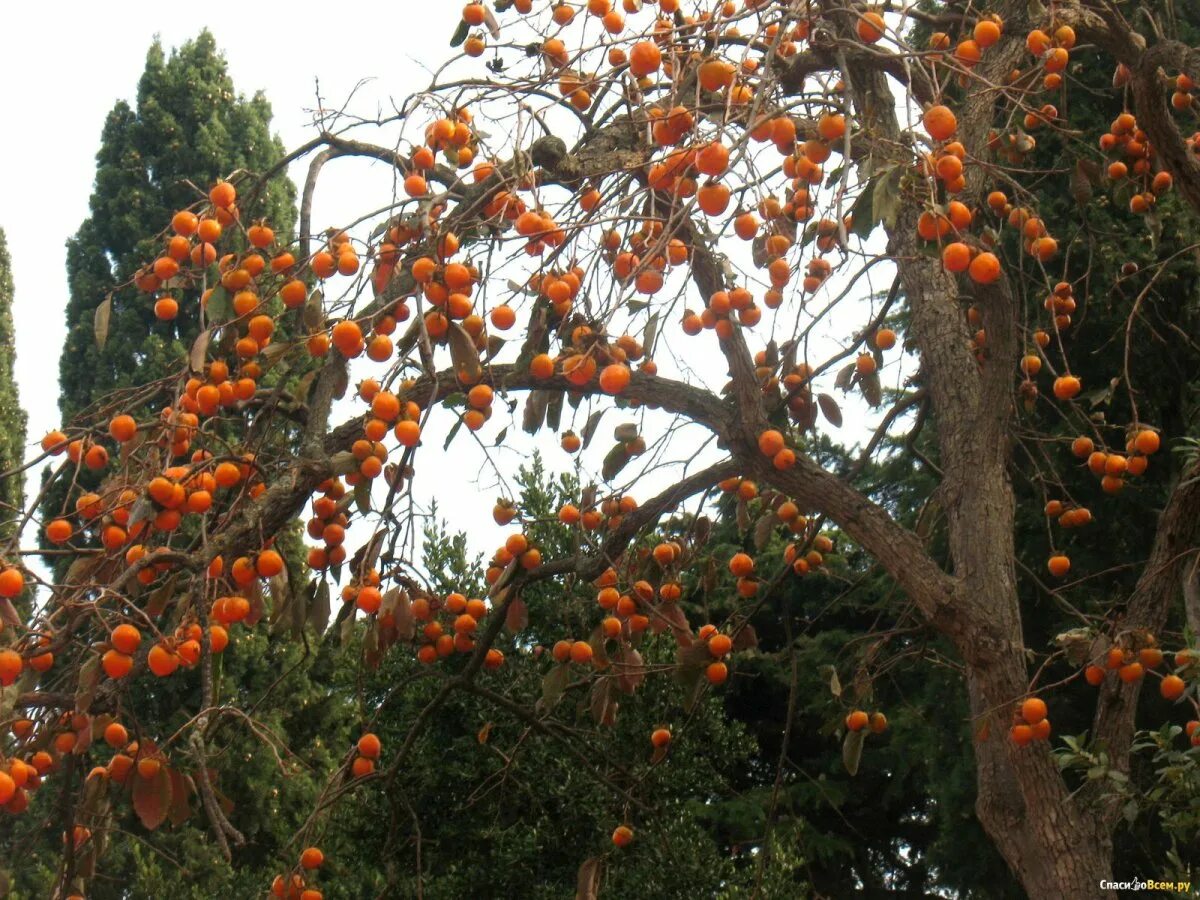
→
(894, 211, 1111, 899)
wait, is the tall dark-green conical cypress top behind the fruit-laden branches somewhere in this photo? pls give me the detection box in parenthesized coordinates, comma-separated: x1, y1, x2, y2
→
(59, 31, 295, 422)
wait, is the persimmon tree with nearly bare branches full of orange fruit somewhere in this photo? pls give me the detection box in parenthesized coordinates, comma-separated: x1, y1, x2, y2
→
(0, 0, 1200, 898)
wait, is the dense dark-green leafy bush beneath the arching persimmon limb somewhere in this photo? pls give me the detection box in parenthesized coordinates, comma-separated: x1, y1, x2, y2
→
(309, 458, 772, 899)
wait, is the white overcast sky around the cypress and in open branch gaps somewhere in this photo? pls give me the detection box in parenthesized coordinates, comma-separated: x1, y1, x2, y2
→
(0, 0, 899, 578)
